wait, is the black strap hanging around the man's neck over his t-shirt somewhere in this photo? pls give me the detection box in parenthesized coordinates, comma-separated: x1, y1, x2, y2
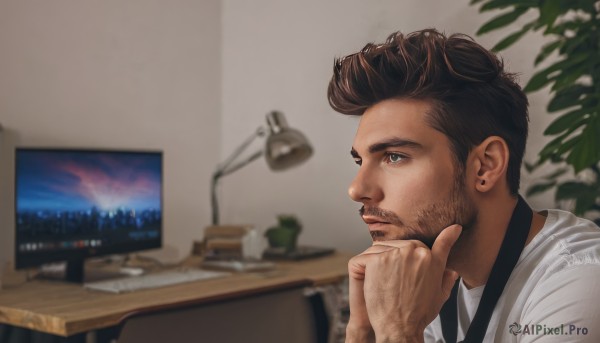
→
(440, 195, 533, 343)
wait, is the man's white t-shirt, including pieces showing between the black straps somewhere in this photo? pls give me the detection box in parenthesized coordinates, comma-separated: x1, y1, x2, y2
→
(425, 210, 600, 343)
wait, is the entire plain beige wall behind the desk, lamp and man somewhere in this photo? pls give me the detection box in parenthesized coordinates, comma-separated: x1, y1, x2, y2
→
(0, 0, 553, 262)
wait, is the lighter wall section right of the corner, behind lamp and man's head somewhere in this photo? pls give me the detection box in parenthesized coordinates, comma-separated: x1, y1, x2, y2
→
(221, 0, 551, 251)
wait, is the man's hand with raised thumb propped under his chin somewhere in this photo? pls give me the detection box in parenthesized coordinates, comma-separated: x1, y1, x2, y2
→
(349, 225, 462, 342)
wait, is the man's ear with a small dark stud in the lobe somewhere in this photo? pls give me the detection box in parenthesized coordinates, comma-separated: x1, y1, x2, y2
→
(471, 136, 510, 192)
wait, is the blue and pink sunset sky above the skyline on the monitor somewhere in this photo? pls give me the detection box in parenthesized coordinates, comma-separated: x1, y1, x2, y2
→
(16, 149, 162, 212)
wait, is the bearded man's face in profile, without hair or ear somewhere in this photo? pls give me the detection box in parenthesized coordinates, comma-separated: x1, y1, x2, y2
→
(348, 99, 477, 247)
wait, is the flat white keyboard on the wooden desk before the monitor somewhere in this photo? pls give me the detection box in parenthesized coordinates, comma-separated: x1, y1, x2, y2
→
(83, 269, 231, 293)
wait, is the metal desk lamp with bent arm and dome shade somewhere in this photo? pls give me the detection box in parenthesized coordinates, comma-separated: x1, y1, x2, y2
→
(211, 111, 313, 225)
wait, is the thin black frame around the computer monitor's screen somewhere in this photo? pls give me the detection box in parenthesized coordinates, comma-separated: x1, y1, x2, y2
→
(14, 146, 165, 269)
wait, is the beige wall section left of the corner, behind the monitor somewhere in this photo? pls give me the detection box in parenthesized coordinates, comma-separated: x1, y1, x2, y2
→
(0, 0, 221, 262)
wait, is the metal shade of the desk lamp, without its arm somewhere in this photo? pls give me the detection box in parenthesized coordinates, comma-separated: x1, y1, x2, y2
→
(265, 111, 313, 171)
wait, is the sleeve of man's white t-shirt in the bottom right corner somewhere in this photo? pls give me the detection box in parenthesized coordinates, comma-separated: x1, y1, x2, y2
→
(517, 262, 600, 343)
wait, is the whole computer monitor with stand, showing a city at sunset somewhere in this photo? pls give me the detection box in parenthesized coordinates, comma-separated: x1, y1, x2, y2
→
(15, 148, 163, 282)
